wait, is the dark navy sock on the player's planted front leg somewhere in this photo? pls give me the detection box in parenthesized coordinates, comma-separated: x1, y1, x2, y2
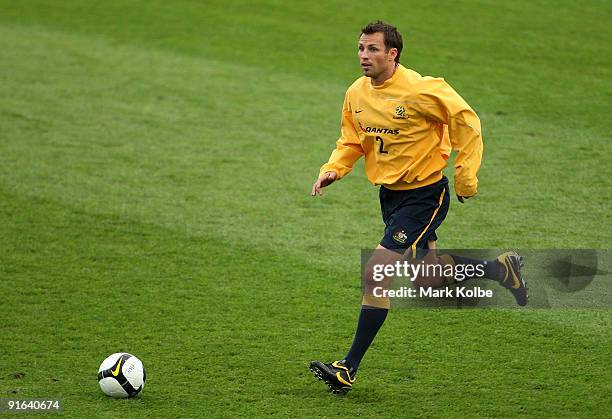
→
(344, 306, 389, 374)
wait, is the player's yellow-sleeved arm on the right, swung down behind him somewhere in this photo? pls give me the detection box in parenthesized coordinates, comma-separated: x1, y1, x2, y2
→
(415, 77, 483, 202)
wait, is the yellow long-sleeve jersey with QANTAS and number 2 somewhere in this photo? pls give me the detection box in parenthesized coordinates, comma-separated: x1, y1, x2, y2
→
(320, 65, 482, 196)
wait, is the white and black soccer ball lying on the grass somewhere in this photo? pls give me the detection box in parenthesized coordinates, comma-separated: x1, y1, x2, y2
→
(98, 352, 147, 398)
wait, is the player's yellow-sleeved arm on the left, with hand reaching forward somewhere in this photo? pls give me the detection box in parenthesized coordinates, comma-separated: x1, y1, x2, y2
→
(311, 92, 364, 196)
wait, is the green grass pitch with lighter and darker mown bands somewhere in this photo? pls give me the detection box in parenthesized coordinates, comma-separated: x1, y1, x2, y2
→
(0, 0, 612, 417)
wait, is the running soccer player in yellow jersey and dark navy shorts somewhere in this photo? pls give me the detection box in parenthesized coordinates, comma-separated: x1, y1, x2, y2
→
(310, 21, 527, 394)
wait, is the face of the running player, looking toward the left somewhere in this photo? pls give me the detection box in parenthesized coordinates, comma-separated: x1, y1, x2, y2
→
(358, 32, 397, 84)
